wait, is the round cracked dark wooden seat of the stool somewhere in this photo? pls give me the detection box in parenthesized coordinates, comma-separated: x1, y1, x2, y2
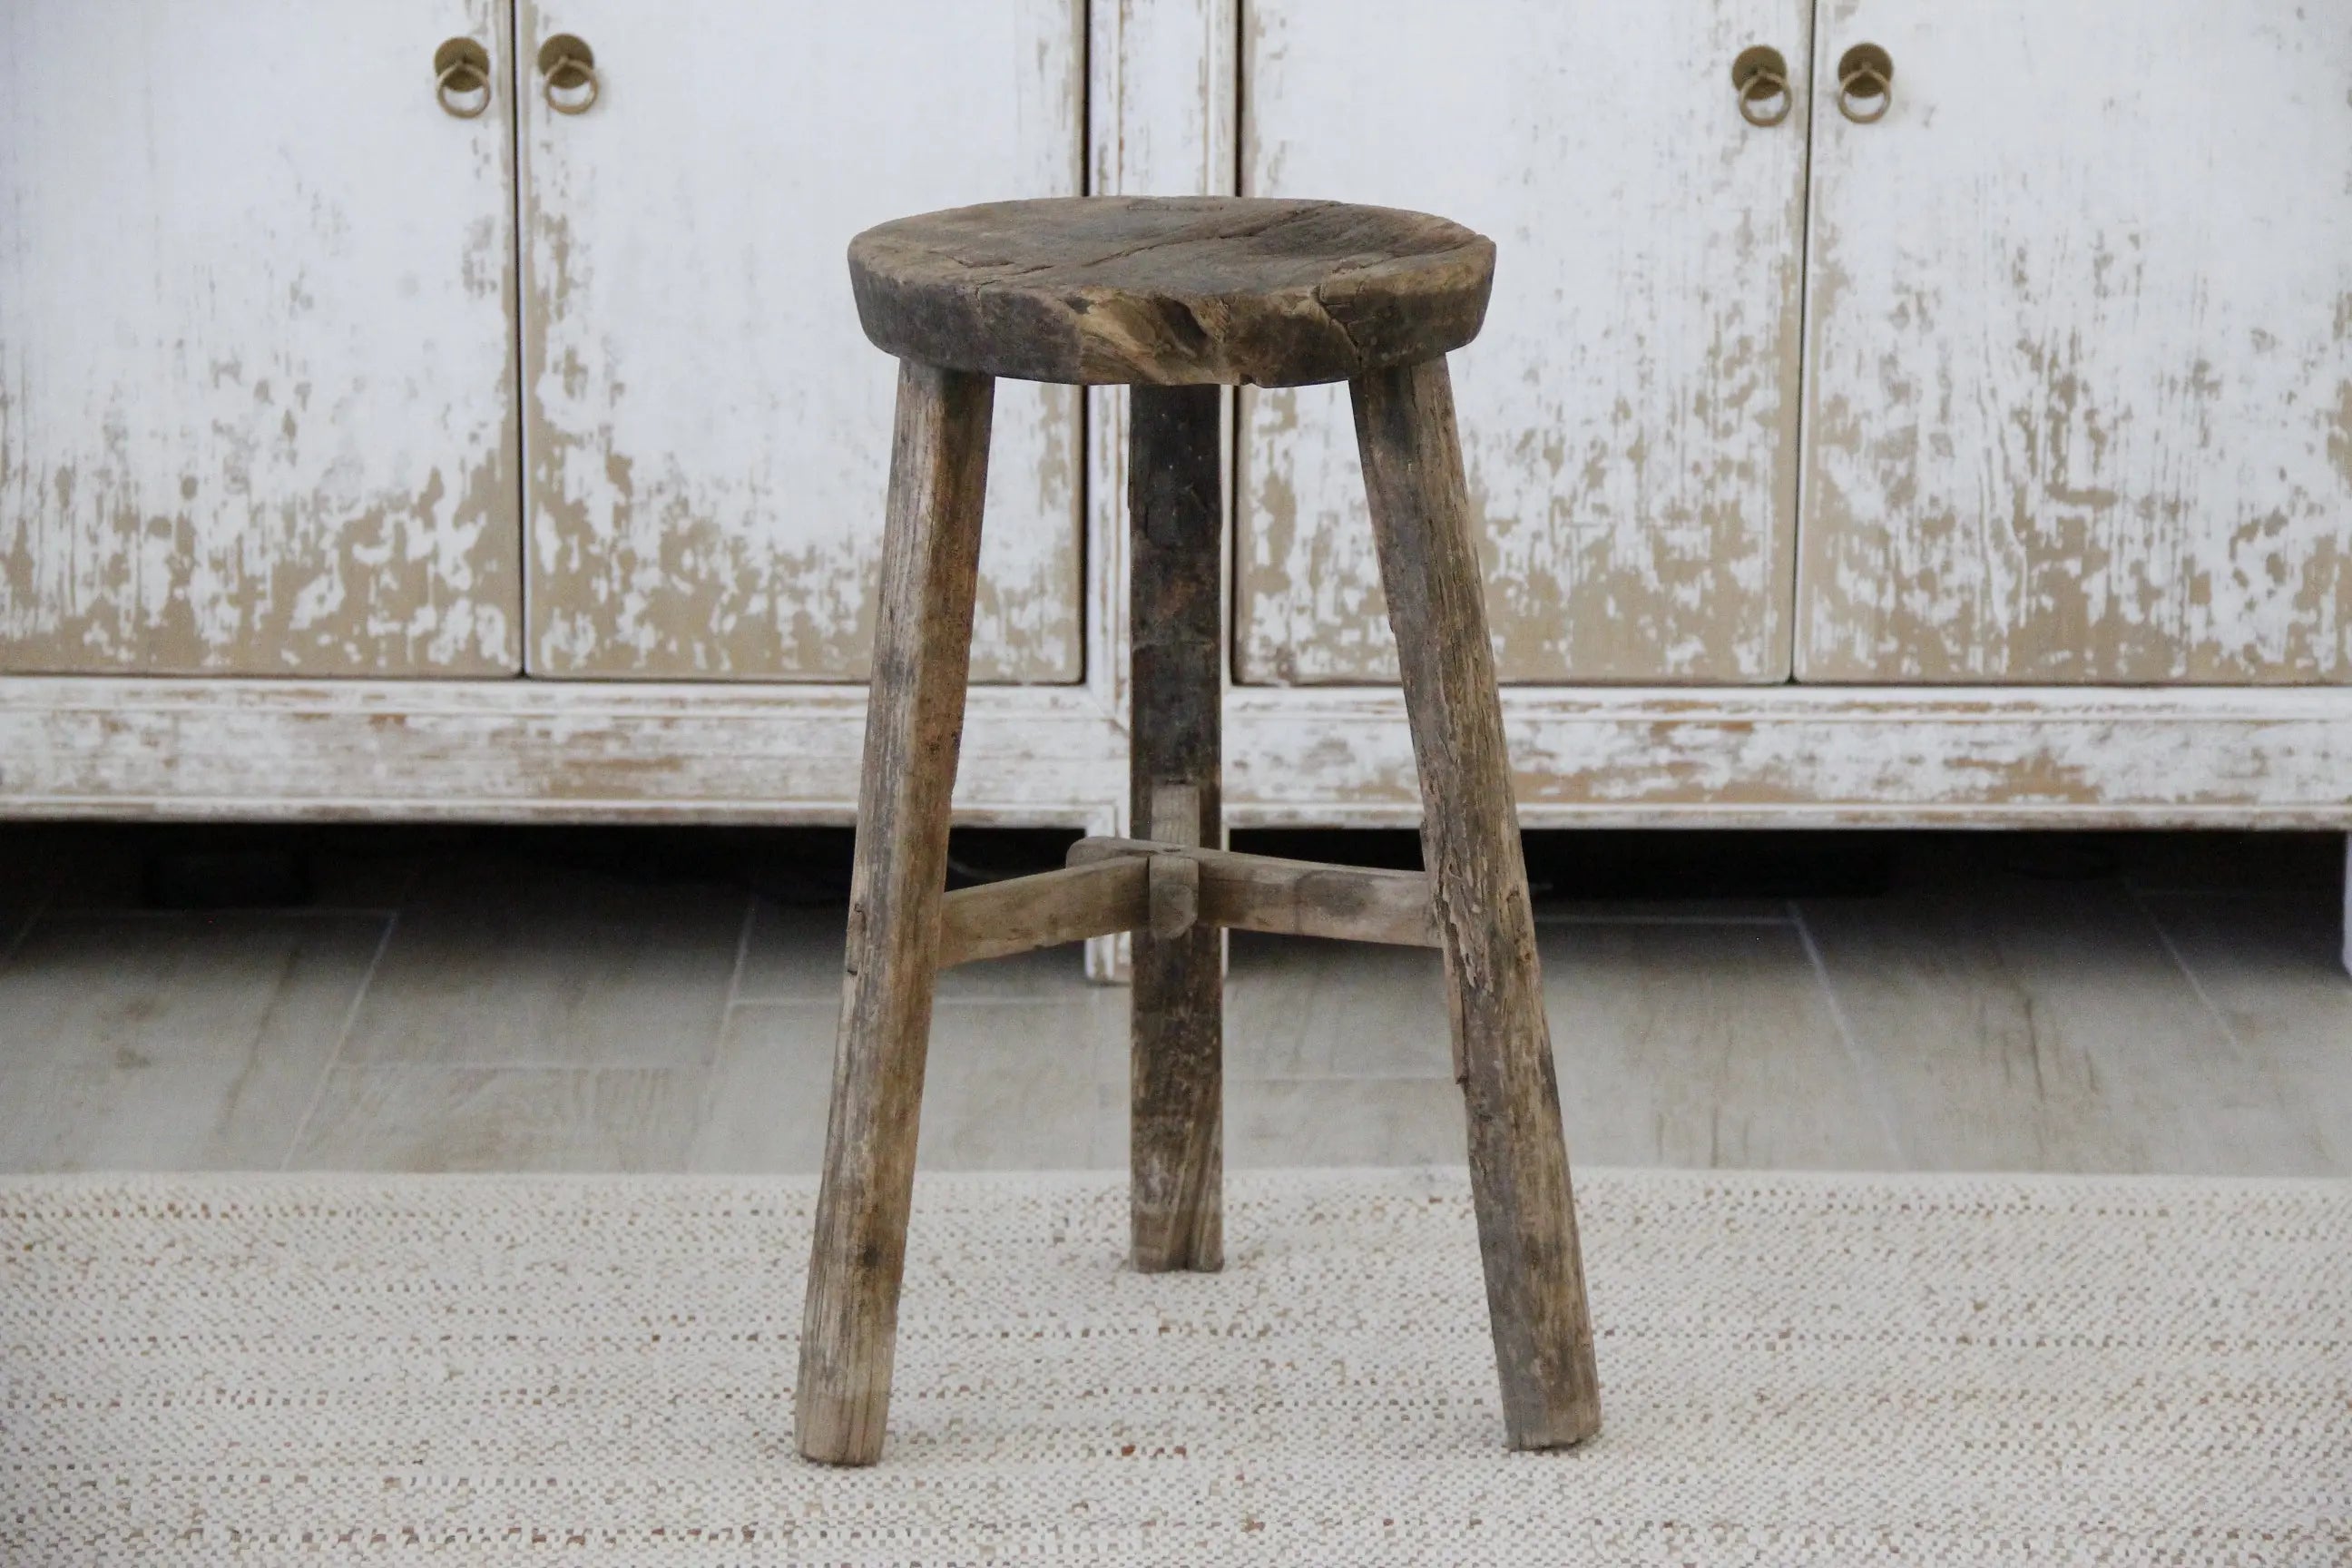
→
(849, 198, 1494, 386)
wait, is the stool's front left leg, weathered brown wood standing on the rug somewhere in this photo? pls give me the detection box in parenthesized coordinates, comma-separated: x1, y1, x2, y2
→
(798, 365, 995, 1465)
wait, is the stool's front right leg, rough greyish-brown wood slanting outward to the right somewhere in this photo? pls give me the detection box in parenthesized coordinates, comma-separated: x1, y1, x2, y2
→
(1350, 359, 1602, 1448)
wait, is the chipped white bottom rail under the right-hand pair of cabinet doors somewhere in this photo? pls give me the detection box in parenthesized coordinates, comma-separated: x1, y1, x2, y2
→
(1225, 686, 2352, 828)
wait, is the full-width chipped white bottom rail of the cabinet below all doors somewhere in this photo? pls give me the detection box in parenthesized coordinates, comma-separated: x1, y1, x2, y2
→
(0, 677, 2352, 830)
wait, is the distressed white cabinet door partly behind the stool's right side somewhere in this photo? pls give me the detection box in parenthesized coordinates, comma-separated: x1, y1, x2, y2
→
(1235, 0, 1811, 681)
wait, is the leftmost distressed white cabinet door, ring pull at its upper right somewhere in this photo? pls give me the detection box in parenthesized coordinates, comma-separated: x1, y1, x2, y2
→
(0, 0, 522, 675)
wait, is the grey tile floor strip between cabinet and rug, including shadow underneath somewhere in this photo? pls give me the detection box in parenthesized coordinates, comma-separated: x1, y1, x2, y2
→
(0, 825, 2352, 1175)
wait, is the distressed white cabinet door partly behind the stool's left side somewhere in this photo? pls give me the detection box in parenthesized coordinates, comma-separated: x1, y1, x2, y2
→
(520, 0, 1084, 681)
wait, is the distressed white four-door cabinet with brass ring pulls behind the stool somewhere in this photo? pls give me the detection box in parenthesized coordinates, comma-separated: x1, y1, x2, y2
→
(0, 0, 2352, 945)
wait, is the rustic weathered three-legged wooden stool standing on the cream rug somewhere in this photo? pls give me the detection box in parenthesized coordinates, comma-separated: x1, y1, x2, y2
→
(798, 198, 1600, 1465)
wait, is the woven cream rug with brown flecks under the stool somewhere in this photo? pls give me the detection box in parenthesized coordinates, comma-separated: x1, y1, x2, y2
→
(0, 1171, 2352, 1568)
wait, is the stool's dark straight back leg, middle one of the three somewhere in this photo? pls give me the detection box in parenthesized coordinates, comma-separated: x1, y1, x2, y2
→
(1127, 386, 1225, 1274)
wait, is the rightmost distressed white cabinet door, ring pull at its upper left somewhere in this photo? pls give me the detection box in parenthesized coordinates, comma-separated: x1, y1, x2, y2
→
(1797, 0, 2352, 681)
